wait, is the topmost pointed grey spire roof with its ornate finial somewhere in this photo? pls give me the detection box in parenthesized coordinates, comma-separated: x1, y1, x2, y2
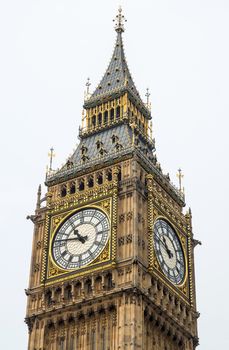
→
(84, 8, 149, 118)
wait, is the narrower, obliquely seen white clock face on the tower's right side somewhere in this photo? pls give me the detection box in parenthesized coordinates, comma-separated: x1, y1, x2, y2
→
(153, 219, 185, 284)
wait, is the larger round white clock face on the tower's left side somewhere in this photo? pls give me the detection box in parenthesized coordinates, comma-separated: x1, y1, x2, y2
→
(52, 208, 110, 270)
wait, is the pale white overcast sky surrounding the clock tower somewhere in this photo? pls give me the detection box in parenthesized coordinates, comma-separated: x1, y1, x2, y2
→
(0, 0, 229, 350)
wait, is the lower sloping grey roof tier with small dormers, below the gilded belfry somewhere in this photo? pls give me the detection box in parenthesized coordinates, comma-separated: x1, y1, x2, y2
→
(46, 124, 184, 205)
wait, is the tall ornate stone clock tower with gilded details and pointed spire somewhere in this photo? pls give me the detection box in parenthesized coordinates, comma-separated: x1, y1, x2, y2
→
(26, 9, 199, 350)
